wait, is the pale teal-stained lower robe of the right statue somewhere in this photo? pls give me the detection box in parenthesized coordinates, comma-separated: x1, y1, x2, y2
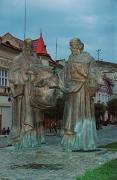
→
(61, 119, 97, 151)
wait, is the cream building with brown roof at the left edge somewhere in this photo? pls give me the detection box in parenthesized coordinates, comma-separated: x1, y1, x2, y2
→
(0, 33, 21, 131)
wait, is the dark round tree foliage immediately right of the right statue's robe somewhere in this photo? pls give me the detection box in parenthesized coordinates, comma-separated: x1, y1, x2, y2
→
(95, 103, 106, 118)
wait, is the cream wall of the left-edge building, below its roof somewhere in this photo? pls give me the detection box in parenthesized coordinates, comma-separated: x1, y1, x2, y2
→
(0, 45, 19, 132)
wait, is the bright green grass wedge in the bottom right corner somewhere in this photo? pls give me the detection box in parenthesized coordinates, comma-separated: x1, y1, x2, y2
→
(77, 159, 117, 180)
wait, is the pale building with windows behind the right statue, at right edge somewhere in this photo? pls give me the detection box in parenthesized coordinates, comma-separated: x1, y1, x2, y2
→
(94, 61, 117, 104)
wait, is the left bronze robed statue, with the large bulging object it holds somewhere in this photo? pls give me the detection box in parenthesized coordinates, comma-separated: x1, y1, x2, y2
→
(9, 39, 58, 149)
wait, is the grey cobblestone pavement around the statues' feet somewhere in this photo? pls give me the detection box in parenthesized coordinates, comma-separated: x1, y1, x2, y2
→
(0, 126, 117, 180)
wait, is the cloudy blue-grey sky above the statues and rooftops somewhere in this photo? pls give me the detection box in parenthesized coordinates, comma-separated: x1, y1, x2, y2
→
(0, 0, 117, 63)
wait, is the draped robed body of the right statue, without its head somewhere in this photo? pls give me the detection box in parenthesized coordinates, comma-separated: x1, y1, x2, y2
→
(59, 52, 99, 150)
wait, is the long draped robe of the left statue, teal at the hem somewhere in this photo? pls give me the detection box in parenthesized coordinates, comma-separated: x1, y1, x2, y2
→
(9, 52, 43, 149)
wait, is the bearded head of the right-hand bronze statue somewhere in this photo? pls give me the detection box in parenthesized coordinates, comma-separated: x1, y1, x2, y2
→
(69, 38, 84, 55)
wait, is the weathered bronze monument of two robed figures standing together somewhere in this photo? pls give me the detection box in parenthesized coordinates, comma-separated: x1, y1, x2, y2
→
(9, 38, 100, 150)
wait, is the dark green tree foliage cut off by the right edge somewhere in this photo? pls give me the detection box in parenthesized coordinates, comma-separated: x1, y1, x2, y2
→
(107, 99, 117, 115)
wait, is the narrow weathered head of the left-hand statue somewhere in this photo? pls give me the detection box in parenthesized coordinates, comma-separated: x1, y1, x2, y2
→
(23, 39, 33, 55)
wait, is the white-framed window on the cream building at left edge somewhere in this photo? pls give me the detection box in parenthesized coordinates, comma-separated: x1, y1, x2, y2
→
(0, 68, 8, 86)
